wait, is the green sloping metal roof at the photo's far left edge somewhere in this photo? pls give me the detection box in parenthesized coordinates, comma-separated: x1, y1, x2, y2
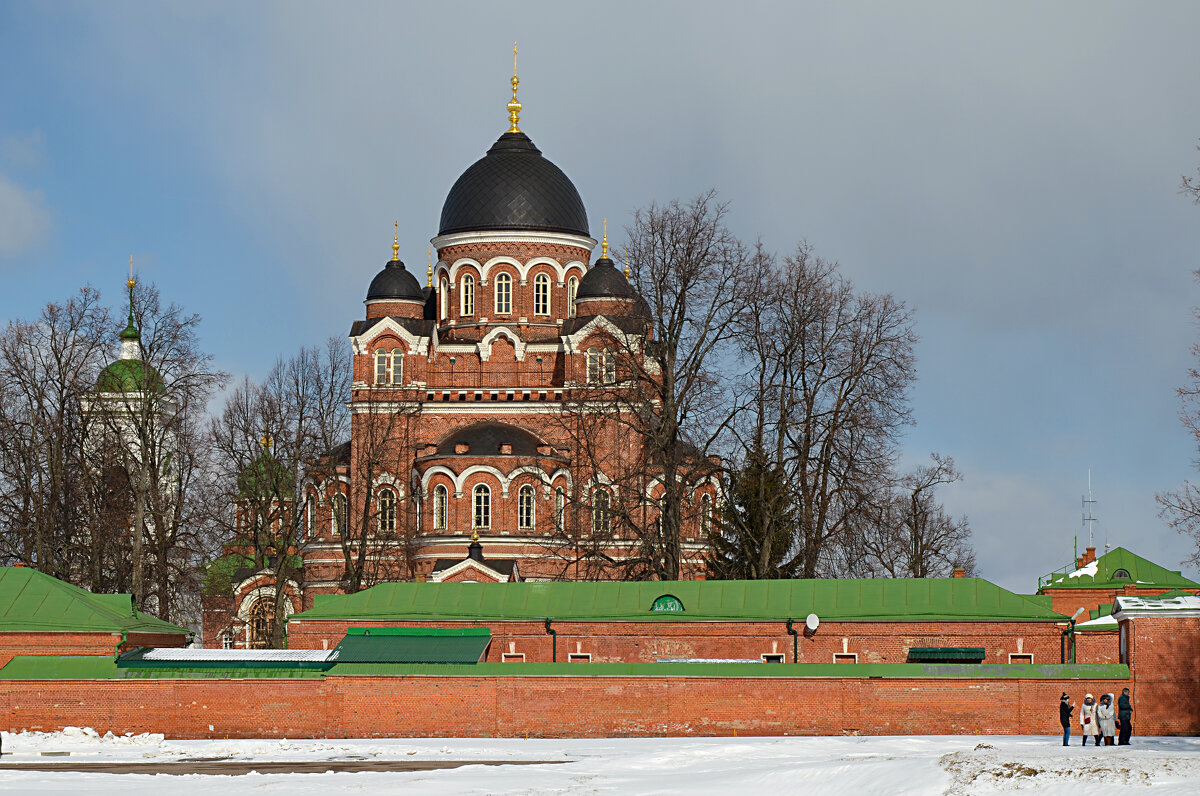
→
(0, 567, 188, 635)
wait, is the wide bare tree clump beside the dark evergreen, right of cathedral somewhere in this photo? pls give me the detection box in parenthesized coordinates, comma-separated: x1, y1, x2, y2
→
(714, 243, 916, 577)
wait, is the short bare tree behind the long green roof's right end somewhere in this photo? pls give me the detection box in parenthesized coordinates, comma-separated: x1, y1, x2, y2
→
(844, 454, 974, 577)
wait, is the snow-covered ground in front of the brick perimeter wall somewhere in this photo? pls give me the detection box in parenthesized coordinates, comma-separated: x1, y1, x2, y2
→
(0, 729, 1200, 796)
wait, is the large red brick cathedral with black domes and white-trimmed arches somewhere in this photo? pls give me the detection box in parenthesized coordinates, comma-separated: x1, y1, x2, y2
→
(205, 77, 718, 647)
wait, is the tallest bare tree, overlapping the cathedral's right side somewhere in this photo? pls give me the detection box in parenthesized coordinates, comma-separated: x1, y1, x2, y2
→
(563, 191, 748, 580)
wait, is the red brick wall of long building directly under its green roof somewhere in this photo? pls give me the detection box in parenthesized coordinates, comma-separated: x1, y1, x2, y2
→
(288, 620, 1070, 664)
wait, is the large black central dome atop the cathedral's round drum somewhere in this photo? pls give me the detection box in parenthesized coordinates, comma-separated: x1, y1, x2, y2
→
(438, 132, 588, 237)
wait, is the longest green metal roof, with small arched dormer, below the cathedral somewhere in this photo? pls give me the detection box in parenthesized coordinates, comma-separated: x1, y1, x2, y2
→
(289, 577, 1066, 623)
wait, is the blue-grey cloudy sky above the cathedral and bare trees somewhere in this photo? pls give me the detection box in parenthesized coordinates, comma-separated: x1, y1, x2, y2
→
(0, 0, 1200, 592)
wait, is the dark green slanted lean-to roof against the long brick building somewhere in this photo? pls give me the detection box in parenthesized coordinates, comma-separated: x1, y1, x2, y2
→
(329, 628, 492, 664)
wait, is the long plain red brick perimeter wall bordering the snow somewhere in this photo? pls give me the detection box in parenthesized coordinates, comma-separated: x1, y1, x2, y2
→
(0, 676, 1132, 738)
